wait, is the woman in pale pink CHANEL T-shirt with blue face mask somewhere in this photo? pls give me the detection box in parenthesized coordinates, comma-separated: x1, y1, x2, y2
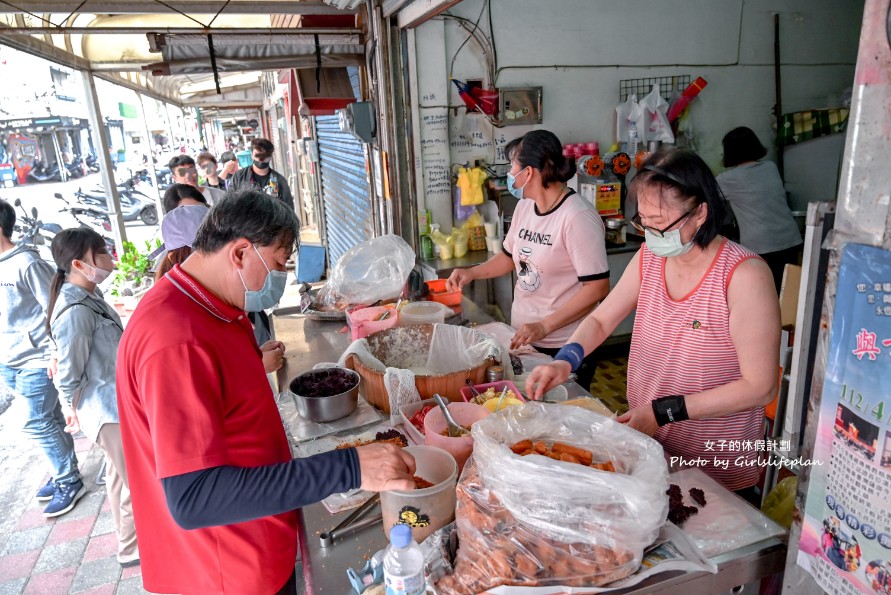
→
(446, 130, 609, 389)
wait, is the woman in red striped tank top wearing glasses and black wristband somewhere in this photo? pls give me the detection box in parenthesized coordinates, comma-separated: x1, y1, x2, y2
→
(527, 149, 780, 497)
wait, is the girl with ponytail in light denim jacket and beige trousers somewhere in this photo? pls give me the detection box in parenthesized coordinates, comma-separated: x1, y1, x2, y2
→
(46, 228, 139, 568)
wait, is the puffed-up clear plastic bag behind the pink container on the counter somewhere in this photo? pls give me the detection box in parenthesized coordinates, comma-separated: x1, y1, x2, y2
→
(324, 234, 415, 305)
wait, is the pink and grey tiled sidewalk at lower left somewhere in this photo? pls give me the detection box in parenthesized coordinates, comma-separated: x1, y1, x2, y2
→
(0, 396, 146, 595)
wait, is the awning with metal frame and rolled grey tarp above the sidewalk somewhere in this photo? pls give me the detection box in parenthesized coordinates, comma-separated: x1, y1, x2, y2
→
(0, 0, 364, 106)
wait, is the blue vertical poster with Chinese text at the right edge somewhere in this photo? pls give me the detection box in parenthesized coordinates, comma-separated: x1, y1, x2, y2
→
(798, 244, 891, 595)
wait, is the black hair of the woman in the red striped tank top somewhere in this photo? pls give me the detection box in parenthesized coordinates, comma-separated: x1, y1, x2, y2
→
(631, 149, 726, 248)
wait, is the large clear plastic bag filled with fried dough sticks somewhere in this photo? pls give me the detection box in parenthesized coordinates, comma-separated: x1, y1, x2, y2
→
(437, 403, 668, 593)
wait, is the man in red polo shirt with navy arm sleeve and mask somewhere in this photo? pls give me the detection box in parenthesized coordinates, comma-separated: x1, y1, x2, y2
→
(117, 190, 414, 595)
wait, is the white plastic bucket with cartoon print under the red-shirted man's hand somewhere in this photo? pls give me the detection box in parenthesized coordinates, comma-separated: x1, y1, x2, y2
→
(381, 446, 458, 543)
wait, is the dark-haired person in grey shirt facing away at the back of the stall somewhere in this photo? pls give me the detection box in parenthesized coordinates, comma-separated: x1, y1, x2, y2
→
(717, 126, 803, 292)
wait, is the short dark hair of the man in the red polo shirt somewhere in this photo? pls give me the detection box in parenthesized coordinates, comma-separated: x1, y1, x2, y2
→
(192, 189, 300, 254)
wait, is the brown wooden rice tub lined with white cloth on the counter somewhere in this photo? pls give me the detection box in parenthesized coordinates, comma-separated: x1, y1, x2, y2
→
(346, 324, 493, 413)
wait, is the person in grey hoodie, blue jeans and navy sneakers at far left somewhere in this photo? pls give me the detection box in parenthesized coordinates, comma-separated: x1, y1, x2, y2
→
(0, 200, 87, 517)
